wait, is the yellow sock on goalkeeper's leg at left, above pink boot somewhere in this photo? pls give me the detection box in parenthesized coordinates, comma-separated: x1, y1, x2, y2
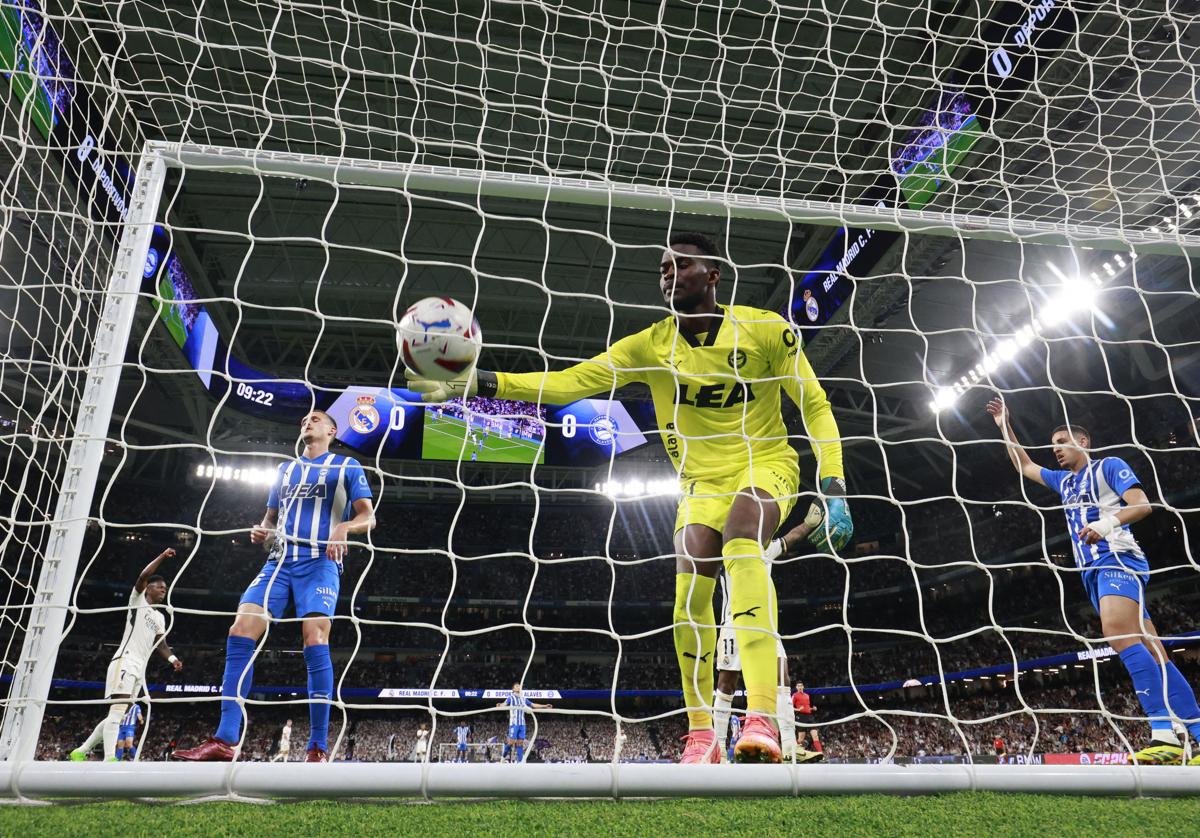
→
(674, 573, 716, 730)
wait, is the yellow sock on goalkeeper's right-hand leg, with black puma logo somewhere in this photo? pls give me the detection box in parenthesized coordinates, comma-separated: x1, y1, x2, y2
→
(721, 538, 779, 718)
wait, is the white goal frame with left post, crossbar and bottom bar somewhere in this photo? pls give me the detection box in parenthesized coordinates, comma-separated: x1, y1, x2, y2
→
(0, 143, 1200, 798)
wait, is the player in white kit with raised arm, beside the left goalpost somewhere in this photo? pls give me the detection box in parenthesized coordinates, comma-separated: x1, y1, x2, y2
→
(71, 547, 184, 762)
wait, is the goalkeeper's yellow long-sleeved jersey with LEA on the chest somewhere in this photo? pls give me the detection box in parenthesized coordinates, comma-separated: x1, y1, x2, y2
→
(497, 305, 845, 480)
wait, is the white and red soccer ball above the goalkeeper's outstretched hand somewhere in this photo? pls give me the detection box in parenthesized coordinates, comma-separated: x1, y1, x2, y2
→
(396, 297, 484, 381)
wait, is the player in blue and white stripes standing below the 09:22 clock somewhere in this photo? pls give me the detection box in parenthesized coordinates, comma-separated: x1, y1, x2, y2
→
(174, 411, 374, 762)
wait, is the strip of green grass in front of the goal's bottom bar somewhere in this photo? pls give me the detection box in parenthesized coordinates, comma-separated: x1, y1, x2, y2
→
(7, 792, 1200, 838)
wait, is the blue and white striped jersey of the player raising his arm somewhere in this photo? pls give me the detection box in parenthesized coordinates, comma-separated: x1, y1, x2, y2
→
(1042, 457, 1146, 570)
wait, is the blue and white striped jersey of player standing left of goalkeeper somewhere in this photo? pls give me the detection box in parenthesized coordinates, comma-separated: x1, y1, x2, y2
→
(266, 451, 371, 562)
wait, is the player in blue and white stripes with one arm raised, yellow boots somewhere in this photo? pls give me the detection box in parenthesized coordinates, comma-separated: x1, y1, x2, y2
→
(988, 399, 1200, 765)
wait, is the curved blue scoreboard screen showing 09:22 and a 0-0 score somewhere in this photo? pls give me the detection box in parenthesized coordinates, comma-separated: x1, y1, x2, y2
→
(150, 227, 654, 466)
